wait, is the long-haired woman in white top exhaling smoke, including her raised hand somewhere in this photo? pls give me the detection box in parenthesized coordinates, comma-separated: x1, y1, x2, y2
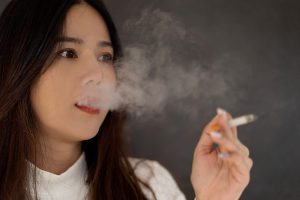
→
(0, 0, 252, 200)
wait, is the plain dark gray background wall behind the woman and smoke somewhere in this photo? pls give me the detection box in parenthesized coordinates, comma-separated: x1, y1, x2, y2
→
(0, 0, 300, 200)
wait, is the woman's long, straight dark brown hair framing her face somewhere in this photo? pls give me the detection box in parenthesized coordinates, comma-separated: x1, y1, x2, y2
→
(0, 0, 155, 200)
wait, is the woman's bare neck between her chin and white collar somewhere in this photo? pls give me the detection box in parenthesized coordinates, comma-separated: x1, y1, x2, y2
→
(35, 139, 82, 175)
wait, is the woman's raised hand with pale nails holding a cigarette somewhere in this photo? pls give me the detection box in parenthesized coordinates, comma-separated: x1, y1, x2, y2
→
(191, 109, 253, 200)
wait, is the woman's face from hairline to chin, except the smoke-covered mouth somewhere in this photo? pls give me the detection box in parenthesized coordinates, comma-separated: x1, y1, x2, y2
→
(31, 3, 116, 142)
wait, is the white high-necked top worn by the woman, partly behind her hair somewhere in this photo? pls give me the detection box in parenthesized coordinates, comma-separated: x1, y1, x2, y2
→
(29, 153, 186, 200)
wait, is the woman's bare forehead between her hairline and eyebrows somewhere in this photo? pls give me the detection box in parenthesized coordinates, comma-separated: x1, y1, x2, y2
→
(64, 3, 110, 41)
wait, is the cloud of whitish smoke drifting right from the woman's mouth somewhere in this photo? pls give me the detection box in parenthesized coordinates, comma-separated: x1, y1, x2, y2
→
(95, 8, 250, 118)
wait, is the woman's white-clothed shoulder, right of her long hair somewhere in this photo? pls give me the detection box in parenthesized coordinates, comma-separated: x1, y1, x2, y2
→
(128, 157, 185, 200)
